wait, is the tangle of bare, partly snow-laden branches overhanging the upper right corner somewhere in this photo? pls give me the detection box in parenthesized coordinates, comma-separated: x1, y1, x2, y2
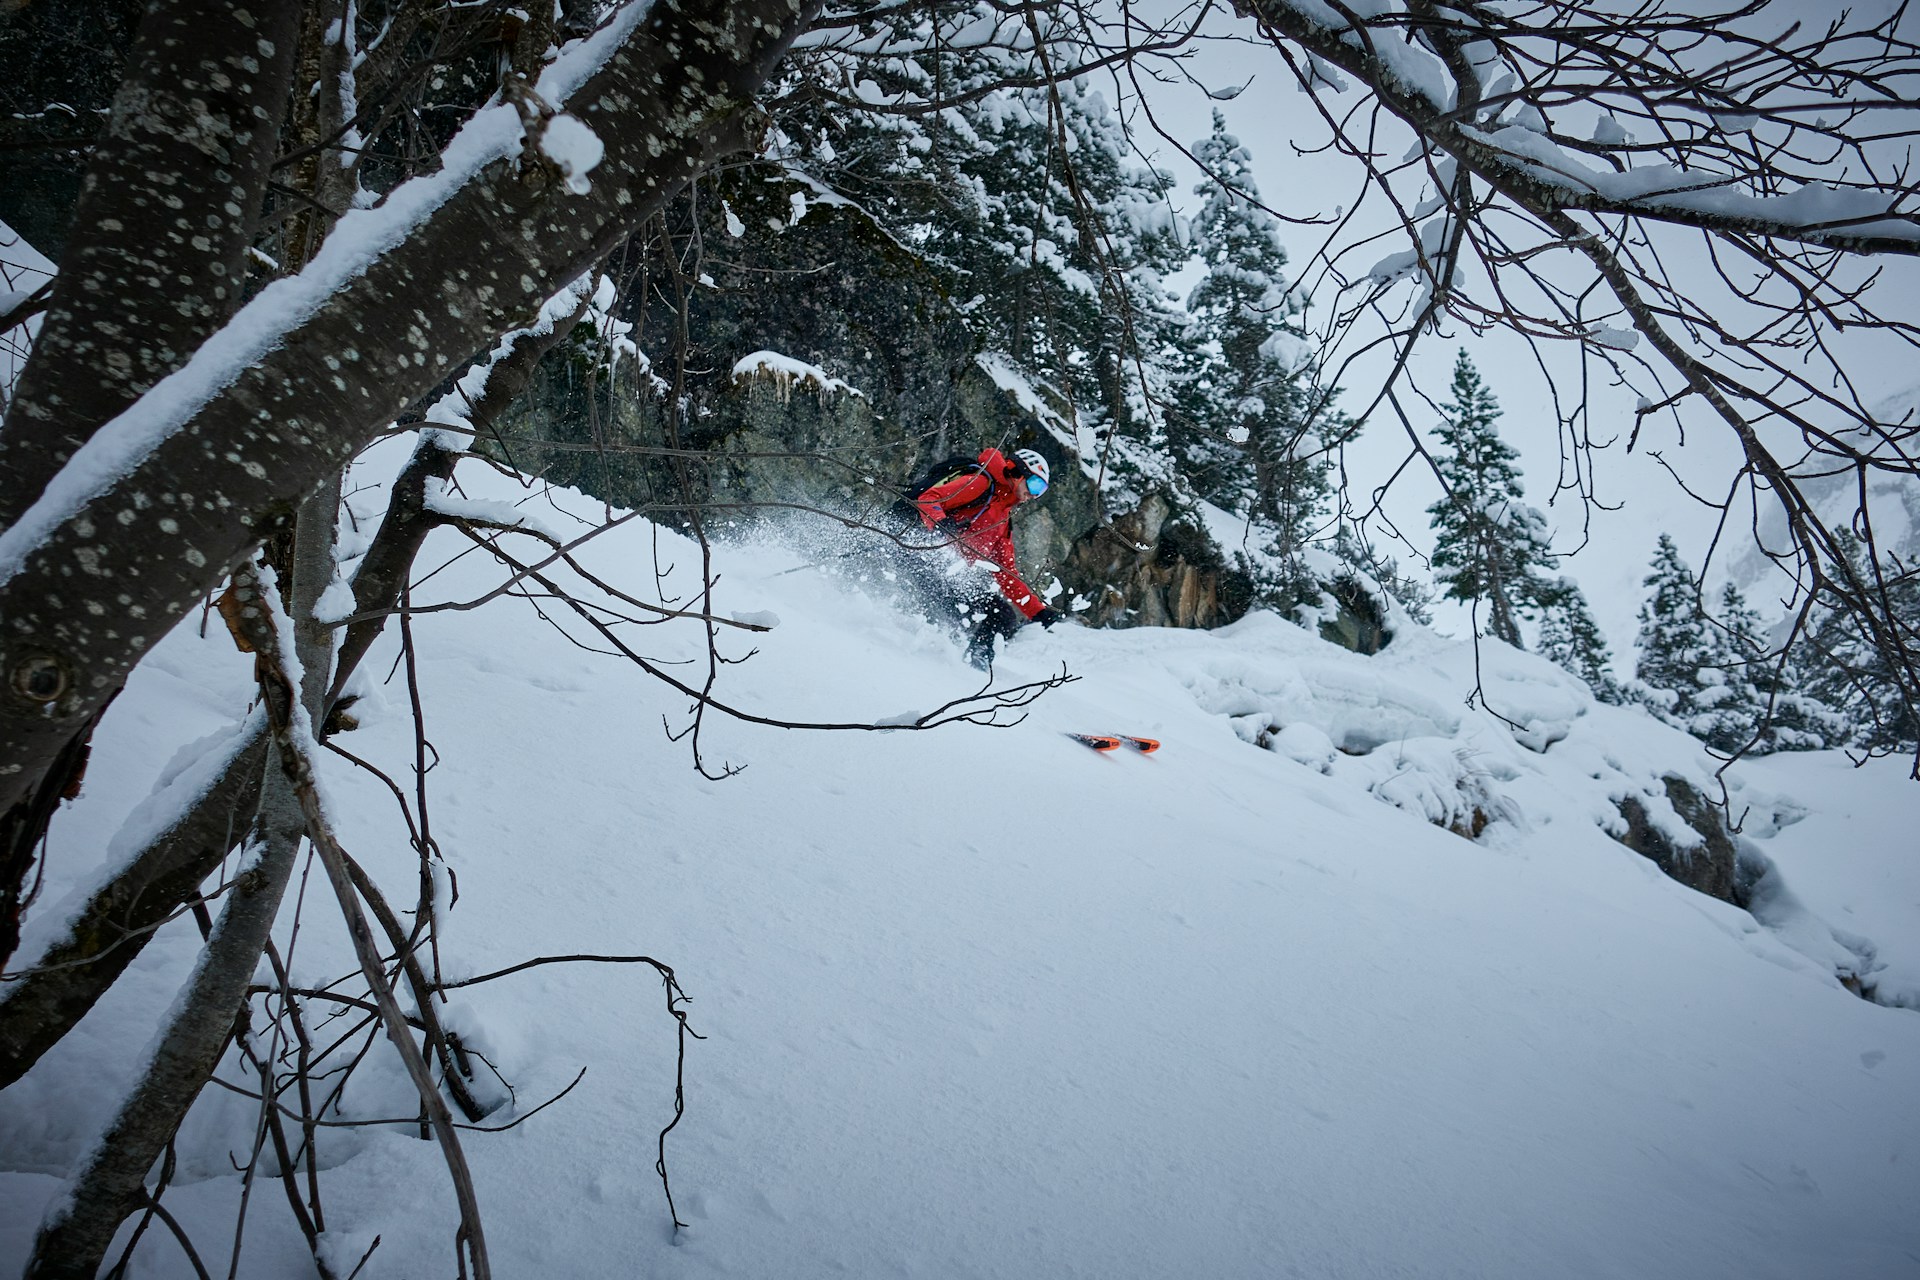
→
(1235, 0, 1920, 744)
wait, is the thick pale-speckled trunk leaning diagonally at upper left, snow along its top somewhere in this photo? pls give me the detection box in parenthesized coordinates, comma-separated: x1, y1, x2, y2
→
(0, 0, 806, 832)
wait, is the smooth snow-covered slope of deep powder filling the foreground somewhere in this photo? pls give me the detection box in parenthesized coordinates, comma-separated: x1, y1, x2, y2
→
(0, 445, 1920, 1278)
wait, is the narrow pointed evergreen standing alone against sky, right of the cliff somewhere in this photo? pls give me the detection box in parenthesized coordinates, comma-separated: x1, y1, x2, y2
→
(1427, 349, 1553, 649)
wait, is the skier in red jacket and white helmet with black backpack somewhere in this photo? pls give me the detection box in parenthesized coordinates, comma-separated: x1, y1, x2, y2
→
(897, 447, 1062, 672)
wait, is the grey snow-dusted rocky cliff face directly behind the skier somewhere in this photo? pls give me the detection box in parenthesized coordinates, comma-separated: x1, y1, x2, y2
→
(486, 312, 1246, 628)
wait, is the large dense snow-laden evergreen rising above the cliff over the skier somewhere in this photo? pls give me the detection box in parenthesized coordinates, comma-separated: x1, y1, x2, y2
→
(747, 23, 1185, 460)
